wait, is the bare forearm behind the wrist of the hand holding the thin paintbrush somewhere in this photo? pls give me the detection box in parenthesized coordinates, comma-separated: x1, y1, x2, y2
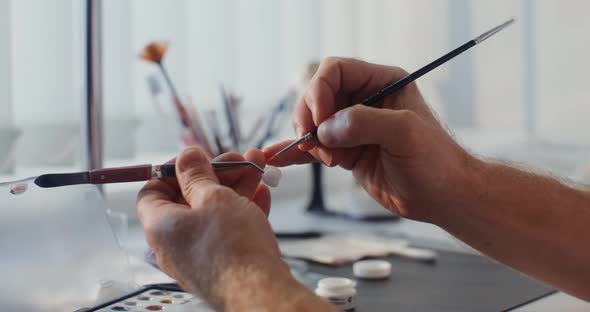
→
(435, 161, 590, 300)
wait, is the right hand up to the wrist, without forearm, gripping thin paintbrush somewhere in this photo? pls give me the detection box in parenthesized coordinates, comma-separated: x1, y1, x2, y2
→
(265, 58, 480, 222)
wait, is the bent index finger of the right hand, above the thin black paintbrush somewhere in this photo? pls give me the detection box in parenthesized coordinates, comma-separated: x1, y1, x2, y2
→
(292, 57, 406, 150)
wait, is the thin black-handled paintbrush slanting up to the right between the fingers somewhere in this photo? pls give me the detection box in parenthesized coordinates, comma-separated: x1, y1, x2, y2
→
(271, 18, 515, 158)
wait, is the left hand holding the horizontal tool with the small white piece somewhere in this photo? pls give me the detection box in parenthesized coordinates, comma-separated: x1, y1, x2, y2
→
(137, 148, 338, 311)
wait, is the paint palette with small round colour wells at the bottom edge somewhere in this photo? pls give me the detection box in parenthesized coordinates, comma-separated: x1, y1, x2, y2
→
(87, 287, 213, 312)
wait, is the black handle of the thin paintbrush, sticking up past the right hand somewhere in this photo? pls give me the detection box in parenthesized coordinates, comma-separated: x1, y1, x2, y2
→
(361, 40, 477, 106)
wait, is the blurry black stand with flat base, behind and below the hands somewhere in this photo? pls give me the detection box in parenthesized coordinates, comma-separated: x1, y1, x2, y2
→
(305, 162, 399, 222)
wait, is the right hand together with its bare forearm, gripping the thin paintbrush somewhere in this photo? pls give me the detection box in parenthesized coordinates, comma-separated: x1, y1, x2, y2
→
(265, 58, 590, 300)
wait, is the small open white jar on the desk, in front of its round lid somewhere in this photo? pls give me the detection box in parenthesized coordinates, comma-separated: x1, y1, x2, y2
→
(315, 277, 356, 311)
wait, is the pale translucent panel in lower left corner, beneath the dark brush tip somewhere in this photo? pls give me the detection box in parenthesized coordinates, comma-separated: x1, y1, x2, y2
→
(0, 185, 134, 311)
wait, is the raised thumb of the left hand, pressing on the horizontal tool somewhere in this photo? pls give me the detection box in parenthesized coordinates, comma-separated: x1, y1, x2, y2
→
(176, 147, 219, 208)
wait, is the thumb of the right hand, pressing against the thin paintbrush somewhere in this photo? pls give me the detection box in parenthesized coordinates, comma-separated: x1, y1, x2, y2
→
(318, 104, 422, 149)
